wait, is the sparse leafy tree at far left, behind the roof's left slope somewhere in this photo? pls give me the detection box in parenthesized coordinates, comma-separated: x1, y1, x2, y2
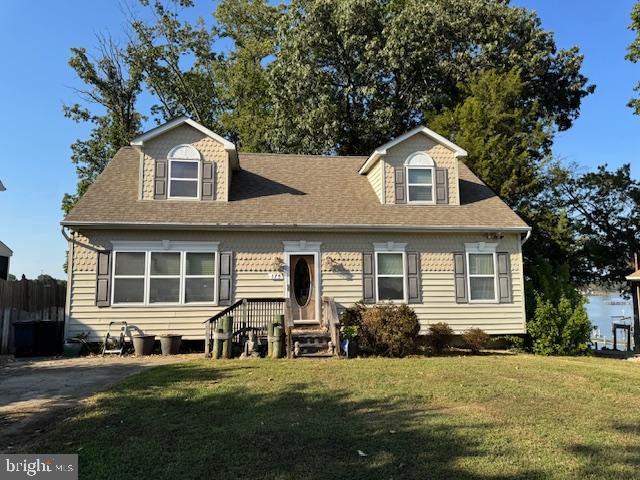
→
(62, 37, 142, 213)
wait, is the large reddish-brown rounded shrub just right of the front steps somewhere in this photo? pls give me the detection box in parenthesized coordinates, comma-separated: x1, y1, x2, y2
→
(358, 305, 420, 357)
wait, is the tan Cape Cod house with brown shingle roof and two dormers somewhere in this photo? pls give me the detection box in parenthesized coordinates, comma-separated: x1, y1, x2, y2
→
(62, 118, 530, 340)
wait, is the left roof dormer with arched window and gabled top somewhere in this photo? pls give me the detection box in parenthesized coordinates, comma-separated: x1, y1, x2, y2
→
(131, 117, 239, 202)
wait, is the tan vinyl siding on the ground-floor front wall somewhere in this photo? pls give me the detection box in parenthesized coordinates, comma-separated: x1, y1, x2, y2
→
(67, 231, 525, 341)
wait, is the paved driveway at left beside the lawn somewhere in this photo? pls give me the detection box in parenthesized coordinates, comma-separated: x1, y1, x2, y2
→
(0, 354, 202, 453)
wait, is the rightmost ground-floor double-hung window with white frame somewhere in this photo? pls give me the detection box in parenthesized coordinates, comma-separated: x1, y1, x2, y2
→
(467, 245, 497, 302)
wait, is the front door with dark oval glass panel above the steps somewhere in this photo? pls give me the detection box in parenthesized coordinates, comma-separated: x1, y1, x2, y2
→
(289, 255, 317, 323)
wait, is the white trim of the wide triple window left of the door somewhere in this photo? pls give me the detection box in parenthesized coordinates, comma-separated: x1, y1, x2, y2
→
(111, 240, 220, 307)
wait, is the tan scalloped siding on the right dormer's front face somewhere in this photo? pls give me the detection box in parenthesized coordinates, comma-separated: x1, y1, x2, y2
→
(379, 133, 460, 205)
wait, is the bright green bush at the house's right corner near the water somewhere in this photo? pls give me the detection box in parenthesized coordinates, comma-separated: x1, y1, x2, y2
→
(527, 295, 592, 355)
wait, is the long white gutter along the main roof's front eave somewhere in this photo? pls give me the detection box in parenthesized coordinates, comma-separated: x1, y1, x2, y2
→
(61, 221, 531, 233)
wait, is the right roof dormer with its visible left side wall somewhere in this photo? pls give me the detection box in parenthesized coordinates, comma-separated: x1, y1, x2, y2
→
(359, 126, 467, 206)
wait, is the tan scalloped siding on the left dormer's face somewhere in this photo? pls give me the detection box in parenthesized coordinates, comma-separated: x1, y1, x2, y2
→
(142, 125, 230, 201)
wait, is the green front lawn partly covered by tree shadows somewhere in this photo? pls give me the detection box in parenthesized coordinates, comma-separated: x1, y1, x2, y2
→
(26, 355, 640, 480)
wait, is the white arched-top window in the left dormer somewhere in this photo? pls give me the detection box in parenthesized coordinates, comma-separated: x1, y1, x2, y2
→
(167, 145, 200, 198)
